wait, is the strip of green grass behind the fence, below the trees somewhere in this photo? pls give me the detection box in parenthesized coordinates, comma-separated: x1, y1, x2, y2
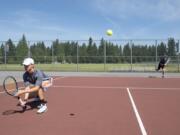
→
(0, 63, 179, 72)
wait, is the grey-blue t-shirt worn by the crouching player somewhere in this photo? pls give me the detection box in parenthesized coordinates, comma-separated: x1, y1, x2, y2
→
(23, 70, 48, 87)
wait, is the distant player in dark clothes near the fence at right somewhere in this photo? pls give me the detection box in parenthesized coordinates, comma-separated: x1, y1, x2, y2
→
(156, 55, 170, 78)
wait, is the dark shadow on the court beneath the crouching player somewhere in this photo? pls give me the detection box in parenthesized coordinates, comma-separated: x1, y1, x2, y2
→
(2, 101, 40, 115)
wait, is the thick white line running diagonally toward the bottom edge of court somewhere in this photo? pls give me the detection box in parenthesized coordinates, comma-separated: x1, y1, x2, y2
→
(127, 88, 147, 135)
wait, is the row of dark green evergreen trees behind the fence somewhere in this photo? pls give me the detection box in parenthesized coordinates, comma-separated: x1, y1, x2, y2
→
(0, 35, 179, 63)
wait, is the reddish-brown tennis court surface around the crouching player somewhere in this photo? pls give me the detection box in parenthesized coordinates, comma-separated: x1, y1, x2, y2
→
(0, 77, 180, 135)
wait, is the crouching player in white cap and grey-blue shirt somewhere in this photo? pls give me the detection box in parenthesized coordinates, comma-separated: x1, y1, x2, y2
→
(16, 58, 52, 113)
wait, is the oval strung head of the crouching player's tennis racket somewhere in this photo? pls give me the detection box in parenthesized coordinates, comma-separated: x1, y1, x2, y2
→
(3, 76, 18, 97)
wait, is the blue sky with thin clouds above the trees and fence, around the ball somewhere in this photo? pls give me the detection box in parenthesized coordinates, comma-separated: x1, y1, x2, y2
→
(0, 0, 180, 41)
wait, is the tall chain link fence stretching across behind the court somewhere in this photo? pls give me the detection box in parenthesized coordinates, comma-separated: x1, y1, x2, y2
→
(0, 39, 180, 72)
